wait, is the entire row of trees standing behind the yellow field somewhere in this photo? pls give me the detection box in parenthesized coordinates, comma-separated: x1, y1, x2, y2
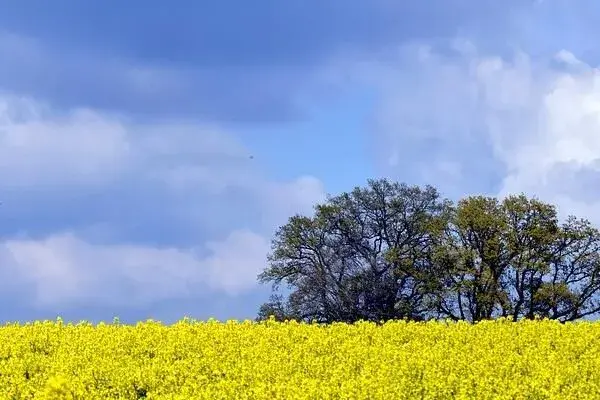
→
(257, 179, 600, 323)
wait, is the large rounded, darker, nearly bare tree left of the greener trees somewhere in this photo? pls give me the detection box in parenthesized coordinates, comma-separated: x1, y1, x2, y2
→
(258, 179, 451, 322)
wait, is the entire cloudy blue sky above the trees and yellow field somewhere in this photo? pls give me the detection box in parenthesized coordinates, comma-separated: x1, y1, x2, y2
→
(0, 0, 600, 323)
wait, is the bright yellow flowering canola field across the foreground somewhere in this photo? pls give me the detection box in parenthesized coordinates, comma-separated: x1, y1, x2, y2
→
(0, 320, 600, 400)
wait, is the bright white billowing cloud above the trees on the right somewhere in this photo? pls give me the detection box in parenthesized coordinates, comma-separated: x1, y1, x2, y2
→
(361, 46, 600, 222)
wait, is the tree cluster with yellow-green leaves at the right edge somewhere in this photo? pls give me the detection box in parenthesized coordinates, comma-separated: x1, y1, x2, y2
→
(434, 195, 600, 322)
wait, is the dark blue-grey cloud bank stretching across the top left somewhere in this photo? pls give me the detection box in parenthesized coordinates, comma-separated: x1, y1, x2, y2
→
(0, 0, 524, 122)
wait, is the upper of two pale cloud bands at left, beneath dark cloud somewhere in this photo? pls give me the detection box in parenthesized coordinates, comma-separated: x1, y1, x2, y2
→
(0, 95, 255, 190)
